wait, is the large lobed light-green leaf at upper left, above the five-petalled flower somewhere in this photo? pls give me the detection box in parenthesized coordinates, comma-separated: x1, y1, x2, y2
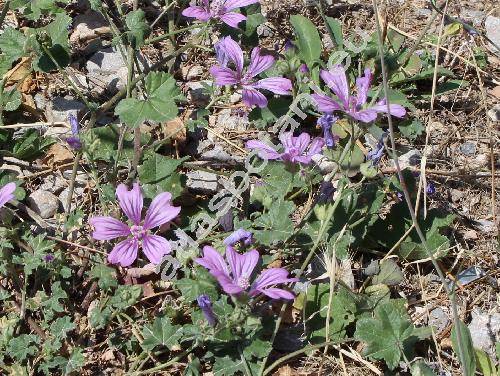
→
(115, 72, 182, 127)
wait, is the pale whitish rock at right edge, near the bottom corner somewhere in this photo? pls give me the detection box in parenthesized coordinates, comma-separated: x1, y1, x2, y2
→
(468, 309, 500, 359)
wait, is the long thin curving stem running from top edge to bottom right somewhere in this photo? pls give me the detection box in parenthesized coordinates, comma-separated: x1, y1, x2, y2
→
(372, 0, 469, 376)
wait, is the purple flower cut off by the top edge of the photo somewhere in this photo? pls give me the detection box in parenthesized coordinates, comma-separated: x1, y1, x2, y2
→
(182, 0, 259, 28)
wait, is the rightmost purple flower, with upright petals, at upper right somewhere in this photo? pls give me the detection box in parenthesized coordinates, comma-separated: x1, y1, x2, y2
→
(312, 65, 406, 123)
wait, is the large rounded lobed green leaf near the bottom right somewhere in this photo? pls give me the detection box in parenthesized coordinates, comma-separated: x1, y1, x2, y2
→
(355, 299, 430, 370)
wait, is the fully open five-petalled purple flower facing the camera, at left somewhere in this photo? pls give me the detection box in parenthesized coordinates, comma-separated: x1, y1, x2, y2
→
(89, 183, 181, 267)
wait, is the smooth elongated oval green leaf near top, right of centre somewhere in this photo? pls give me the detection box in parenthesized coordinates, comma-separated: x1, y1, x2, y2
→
(290, 14, 322, 69)
